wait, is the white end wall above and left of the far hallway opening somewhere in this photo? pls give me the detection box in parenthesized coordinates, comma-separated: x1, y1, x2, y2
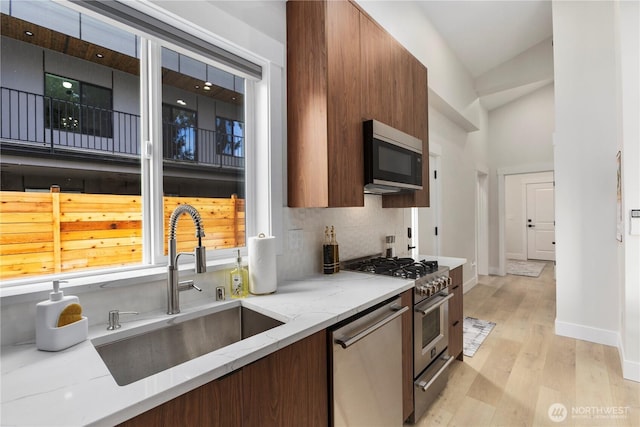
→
(488, 84, 555, 273)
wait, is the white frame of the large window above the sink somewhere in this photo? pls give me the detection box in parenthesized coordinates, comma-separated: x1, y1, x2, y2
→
(0, 0, 282, 290)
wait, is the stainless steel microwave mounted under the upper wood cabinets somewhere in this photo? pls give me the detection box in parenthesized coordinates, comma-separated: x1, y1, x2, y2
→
(363, 120, 422, 194)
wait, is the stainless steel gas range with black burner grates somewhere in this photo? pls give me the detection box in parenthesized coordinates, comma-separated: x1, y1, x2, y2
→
(343, 256, 454, 423)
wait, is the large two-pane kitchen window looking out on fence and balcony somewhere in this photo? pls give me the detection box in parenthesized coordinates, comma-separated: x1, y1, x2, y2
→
(0, 0, 261, 286)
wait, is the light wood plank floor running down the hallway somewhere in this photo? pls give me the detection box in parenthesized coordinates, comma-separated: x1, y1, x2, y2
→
(417, 264, 640, 427)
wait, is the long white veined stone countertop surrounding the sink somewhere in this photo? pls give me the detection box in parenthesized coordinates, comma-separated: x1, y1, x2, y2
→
(0, 272, 416, 426)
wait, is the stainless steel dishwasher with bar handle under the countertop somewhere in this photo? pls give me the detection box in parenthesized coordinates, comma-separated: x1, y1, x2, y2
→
(331, 297, 409, 427)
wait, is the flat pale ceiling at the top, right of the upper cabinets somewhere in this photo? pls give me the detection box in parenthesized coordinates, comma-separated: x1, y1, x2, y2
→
(420, 0, 552, 78)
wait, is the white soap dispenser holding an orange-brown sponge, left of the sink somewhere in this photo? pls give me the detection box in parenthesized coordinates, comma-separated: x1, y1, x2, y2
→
(36, 280, 89, 351)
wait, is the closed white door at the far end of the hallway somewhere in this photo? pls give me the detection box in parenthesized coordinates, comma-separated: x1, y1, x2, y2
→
(526, 182, 556, 261)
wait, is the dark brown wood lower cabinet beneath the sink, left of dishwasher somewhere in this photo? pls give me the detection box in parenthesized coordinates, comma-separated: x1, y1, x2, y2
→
(121, 331, 329, 427)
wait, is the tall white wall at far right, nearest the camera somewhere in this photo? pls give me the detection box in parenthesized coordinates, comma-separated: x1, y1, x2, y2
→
(553, 1, 640, 380)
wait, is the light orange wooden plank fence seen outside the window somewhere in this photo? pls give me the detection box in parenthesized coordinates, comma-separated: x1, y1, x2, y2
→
(0, 188, 245, 280)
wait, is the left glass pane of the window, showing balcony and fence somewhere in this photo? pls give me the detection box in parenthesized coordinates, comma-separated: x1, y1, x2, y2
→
(0, 0, 142, 280)
